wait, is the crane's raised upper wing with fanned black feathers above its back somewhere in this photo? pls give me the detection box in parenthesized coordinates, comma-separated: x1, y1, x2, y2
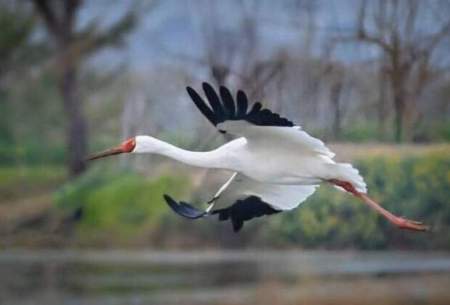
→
(186, 83, 334, 159)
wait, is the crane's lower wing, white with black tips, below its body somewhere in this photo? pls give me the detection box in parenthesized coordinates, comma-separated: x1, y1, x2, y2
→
(164, 174, 317, 232)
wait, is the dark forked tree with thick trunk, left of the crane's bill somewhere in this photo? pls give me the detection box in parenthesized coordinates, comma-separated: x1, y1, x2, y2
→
(32, 0, 136, 176)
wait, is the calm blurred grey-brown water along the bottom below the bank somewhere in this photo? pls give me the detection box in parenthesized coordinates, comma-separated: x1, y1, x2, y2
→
(0, 251, 450, 305)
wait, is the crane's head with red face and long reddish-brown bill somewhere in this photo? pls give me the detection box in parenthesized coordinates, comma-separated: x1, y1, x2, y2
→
(88, 136, 162, 161)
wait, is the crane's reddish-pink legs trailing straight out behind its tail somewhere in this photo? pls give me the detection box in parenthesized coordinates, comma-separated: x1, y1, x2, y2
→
(329, 179, 429, 231)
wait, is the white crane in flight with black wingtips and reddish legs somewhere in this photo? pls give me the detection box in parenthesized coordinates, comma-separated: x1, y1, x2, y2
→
(90, 83, 428, 231)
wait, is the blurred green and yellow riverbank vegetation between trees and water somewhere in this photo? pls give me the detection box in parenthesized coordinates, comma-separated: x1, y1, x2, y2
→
(0, 144, 450, 250)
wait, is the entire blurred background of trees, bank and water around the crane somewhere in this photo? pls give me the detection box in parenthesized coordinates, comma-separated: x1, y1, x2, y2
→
(0, 0, 450, 305)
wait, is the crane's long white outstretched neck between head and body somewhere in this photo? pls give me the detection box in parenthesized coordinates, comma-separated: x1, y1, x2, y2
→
(134, 136, 229, 169)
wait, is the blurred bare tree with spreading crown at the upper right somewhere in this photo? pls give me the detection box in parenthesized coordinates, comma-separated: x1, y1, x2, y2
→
(354, 0, 450, 142)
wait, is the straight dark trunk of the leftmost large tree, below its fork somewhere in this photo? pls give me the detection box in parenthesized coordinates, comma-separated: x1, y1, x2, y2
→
(60, 59, 87, 177)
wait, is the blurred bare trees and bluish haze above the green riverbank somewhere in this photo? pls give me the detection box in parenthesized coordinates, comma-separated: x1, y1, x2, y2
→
(0, 0, 450, 170)
